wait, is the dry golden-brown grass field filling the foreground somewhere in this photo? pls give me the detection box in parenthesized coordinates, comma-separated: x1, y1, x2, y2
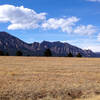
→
(0, 57, 100, 100)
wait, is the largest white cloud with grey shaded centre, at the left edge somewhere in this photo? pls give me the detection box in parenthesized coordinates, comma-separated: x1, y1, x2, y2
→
(0, 5, 46, 30)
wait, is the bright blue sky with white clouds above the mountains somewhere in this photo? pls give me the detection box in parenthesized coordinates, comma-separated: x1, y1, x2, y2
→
(0, 0, 100, 52)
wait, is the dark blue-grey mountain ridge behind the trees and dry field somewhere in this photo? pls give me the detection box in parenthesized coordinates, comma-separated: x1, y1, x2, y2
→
(0, 32, 96, 57)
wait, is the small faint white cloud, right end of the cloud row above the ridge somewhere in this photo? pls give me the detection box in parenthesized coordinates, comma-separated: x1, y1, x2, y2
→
(73, 25, 97, 35)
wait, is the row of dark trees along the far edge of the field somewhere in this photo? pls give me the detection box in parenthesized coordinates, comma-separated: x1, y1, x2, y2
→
(0, 49, 82, 57)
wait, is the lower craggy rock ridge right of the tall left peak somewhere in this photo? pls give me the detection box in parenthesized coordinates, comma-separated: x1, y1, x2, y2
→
(31, 41, 95, 57)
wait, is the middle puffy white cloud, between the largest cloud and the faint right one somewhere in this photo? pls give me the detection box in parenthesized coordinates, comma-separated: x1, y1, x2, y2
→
(42, 17, 79, 33)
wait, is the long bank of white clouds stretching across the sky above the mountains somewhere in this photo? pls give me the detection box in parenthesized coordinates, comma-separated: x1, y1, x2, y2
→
(0, 4, 96, 35)
